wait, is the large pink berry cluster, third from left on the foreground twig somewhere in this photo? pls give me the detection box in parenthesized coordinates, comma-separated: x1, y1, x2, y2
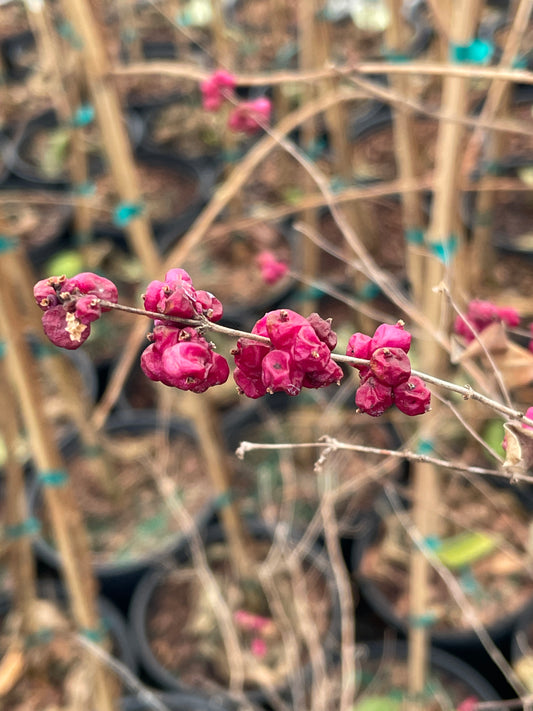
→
(232, 309, 343, 399)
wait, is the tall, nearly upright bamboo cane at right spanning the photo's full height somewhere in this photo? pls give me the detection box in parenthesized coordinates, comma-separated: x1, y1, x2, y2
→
(408, 0, 481, 695)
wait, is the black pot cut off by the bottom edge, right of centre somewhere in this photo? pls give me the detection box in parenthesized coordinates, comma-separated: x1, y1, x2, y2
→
(354, 641, 500, 708)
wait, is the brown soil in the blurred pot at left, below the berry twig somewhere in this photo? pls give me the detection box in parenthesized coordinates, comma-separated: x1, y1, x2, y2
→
(39, 431, 211, 563)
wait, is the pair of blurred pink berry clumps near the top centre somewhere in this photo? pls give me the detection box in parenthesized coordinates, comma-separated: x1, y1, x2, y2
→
(200, 69, 272, 135)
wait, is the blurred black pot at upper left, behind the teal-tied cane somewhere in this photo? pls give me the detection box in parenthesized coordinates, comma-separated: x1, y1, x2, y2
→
(10, 109, 144, 190)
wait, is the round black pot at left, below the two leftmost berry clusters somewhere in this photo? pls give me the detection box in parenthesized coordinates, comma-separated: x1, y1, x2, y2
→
(29, 411, 213, 608)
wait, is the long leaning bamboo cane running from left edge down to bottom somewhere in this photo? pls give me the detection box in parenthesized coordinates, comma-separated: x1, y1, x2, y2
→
(0, 252, 115, 711)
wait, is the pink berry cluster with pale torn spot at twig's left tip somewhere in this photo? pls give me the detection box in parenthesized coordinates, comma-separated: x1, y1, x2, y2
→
(33, 272, 118, 350)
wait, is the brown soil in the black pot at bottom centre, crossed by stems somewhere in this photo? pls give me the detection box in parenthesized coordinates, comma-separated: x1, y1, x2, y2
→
(147, 544, 331, 690)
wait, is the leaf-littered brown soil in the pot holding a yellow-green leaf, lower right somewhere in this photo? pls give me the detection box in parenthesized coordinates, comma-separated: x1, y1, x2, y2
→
(358, 479, 533, 632)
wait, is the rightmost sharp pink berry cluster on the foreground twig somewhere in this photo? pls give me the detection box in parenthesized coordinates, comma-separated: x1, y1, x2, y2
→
(346, 321, 431, 417)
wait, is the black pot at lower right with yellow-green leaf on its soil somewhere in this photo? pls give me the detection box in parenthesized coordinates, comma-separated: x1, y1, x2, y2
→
(350, 483, 533, 657)
